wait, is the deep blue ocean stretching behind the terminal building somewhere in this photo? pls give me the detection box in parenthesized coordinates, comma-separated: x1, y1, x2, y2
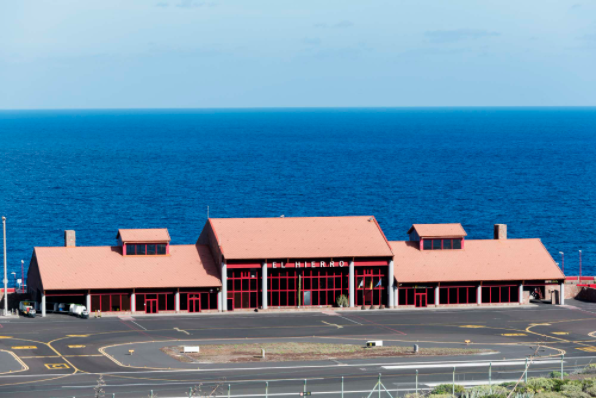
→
(0, 107, 596, 285)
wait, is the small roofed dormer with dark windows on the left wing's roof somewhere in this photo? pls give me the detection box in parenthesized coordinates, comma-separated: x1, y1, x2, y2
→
(116, 229, 170, 256)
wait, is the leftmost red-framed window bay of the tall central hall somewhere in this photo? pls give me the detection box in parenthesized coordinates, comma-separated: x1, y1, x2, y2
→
(226, 268, 261, 310)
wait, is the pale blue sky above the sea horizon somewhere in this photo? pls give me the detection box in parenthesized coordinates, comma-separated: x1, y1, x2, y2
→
(0, 0, 596, 109)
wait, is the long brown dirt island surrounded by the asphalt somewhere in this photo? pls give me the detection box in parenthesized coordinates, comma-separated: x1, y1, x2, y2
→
(161, 342, 487, 363)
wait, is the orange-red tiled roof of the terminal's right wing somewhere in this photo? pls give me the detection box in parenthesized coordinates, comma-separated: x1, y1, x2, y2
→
(390, 238, 565, 283)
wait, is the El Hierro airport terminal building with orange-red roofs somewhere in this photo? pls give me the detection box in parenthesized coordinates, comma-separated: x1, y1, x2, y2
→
(28, 216, 565, 315)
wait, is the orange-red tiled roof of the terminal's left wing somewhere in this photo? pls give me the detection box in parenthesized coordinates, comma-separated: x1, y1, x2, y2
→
(35, 245, 222, 290)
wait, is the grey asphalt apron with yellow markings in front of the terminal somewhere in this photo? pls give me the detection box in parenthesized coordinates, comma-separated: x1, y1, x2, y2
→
(0, 301, 596, 397)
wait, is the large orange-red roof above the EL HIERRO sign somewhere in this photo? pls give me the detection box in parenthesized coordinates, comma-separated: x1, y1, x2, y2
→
(202, 216, 392, 259)
